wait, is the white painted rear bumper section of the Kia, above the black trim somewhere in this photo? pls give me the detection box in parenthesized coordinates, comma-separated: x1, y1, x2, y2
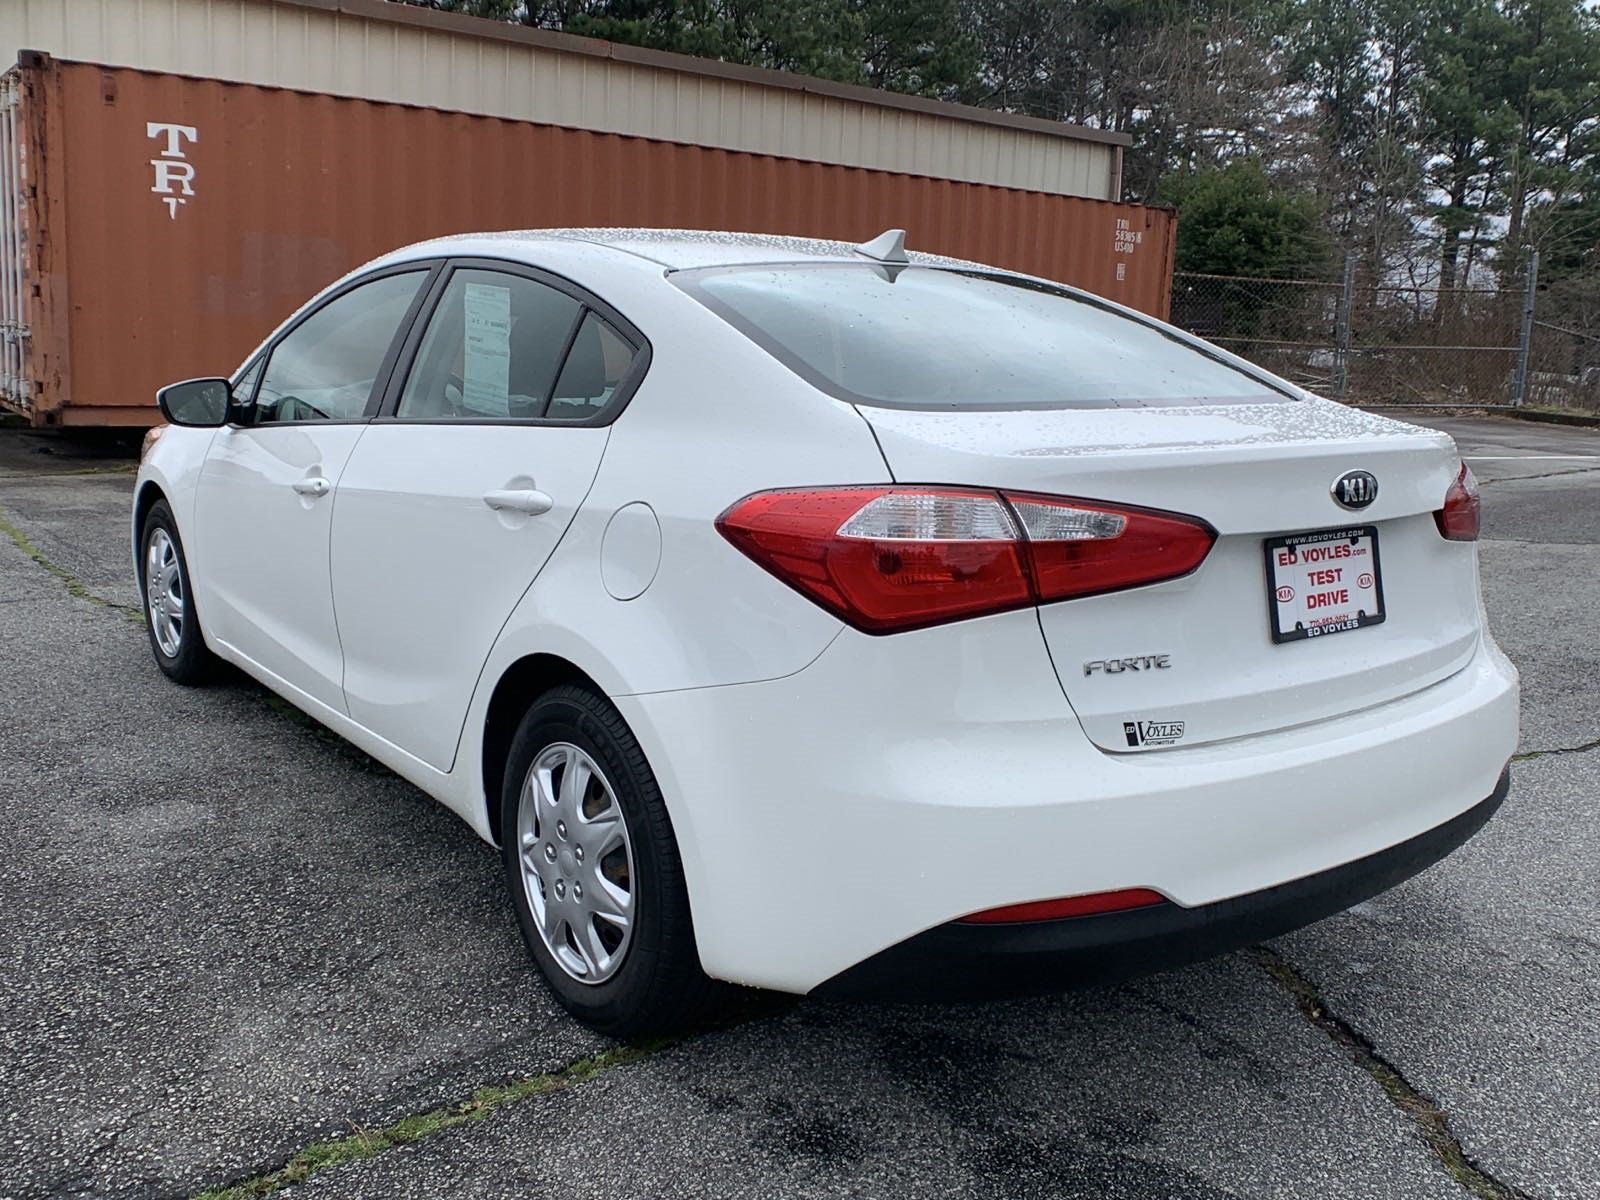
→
(616, 613, 1517, 992)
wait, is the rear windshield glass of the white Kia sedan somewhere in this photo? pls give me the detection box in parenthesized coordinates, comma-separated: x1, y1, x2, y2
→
(672, 262, 1291, 410)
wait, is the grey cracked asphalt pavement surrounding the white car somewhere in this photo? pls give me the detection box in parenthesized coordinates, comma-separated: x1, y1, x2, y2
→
(0, 419, 1600, 1200)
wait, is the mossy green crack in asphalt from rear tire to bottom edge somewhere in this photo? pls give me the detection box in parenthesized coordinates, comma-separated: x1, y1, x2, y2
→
(194, 1037, 683, 1200)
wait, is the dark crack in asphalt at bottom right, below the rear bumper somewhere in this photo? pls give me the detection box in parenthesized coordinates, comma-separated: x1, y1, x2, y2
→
(1250, 946, 1533, 1200)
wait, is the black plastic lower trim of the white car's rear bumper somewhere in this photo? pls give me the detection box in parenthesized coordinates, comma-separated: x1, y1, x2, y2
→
(811, 768, 1510, 1002)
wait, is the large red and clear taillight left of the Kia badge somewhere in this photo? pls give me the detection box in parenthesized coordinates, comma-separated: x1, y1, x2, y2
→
(717, 486, 1216, 634)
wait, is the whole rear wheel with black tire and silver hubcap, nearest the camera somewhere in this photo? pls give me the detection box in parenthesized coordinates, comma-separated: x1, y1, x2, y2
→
(501, 685, 720, 1038)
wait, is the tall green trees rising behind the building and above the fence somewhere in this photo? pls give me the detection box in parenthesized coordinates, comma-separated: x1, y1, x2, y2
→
(406, 0, 1600, 291)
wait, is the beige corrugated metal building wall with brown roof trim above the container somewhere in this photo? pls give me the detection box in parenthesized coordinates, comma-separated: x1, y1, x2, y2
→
(0, 0, 1128, 200)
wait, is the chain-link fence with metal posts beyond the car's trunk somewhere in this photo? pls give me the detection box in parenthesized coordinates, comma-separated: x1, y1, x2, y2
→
(1171, 256, 1600, 411)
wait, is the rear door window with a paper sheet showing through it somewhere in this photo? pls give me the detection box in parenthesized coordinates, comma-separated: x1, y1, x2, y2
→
(395, 269, 582, 421)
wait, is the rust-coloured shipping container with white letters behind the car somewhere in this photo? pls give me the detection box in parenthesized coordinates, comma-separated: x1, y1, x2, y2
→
(0, 51, 1174, 426)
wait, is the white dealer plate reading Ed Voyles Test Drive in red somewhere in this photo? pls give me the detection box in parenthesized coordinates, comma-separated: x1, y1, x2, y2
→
(1266, 525, 1384, 642)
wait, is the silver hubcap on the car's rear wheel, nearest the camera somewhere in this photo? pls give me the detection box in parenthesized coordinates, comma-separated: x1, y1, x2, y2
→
(517, 742, 634, 984)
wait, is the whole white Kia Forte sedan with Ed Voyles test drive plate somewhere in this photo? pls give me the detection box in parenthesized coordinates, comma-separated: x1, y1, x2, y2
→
(133, 230, 1517, 1035)
